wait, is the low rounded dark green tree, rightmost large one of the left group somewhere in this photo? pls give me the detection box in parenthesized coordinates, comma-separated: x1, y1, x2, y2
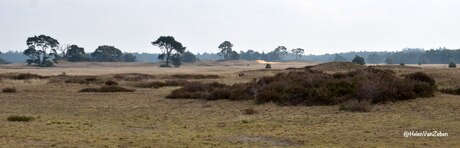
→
(91, 45, 123, 62)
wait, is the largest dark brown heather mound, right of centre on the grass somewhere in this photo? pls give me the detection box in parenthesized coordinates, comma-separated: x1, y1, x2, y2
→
(168, 68, 436, 106)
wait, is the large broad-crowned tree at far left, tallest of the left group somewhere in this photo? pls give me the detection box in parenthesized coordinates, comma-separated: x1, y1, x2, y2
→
(23, 35, 59, 67)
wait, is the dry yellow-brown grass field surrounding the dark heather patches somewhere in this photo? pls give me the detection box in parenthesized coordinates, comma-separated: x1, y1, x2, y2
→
(0, 61, 460, 147)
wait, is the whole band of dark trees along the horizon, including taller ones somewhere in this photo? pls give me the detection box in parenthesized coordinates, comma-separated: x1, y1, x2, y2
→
(0, 35, 460, 67)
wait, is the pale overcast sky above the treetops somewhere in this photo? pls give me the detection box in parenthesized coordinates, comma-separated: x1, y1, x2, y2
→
(0, 0, 460, 54)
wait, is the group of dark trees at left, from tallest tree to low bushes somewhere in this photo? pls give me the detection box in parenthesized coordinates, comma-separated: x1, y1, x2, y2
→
(23, 35, 136, 67)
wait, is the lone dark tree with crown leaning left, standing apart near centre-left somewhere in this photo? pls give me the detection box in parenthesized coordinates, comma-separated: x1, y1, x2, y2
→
(152, 36, 186, 67)
